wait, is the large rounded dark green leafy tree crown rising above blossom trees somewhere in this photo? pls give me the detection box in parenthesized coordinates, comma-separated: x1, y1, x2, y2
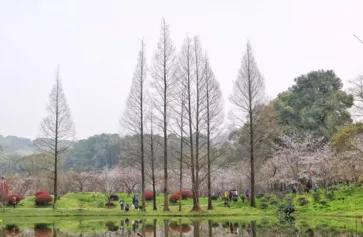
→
(275, 70, 353, 138)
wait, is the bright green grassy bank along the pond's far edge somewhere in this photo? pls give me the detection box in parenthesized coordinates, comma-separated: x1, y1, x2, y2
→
(0, 186, 363, 217)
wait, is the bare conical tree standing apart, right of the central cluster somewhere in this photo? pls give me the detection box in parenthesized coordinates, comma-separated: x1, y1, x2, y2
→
(230, 42, 265, 207)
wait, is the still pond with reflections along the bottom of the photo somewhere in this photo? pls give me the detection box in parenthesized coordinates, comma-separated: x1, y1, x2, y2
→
(0, 217, 363, 237)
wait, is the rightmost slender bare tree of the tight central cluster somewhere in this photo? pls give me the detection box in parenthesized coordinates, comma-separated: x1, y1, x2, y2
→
(203, 57, 223, 210)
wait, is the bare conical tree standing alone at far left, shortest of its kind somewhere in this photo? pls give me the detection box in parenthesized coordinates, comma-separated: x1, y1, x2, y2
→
(35, 70, 75, 209)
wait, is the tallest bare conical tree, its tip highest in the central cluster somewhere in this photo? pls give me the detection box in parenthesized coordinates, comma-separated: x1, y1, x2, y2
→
(152, 19, 176, 211)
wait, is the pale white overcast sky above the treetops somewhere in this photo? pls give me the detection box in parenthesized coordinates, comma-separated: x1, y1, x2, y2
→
(0, 0, 363, 139)
